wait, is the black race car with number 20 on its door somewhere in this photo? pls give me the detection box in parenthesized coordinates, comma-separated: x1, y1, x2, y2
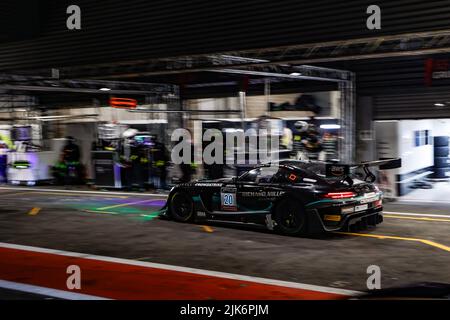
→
(161, 159, 401, 235)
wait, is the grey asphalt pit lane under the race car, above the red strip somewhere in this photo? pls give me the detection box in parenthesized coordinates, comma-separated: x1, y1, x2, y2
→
(0, 189, 450, 299)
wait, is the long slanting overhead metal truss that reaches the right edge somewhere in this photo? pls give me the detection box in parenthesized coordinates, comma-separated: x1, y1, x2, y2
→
(33, 30, 450, 79)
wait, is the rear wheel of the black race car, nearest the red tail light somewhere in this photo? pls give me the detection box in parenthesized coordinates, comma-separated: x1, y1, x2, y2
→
(274, 198, 306, 235)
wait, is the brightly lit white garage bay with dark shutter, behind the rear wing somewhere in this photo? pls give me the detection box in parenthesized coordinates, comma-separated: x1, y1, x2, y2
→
(374, 88, 450, 202)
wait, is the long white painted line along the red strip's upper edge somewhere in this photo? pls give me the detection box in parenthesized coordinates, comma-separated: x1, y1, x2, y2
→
(0, 242, 362, 296)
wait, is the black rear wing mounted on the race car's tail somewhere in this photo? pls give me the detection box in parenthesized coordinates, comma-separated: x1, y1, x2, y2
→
(326, 158, 402, 184)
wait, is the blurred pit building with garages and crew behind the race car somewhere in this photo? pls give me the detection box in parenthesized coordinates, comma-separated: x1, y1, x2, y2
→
(0, 0, 450, 199)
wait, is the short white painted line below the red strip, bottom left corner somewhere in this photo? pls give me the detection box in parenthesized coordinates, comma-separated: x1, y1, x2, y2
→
(0, 280, 110, 300)
